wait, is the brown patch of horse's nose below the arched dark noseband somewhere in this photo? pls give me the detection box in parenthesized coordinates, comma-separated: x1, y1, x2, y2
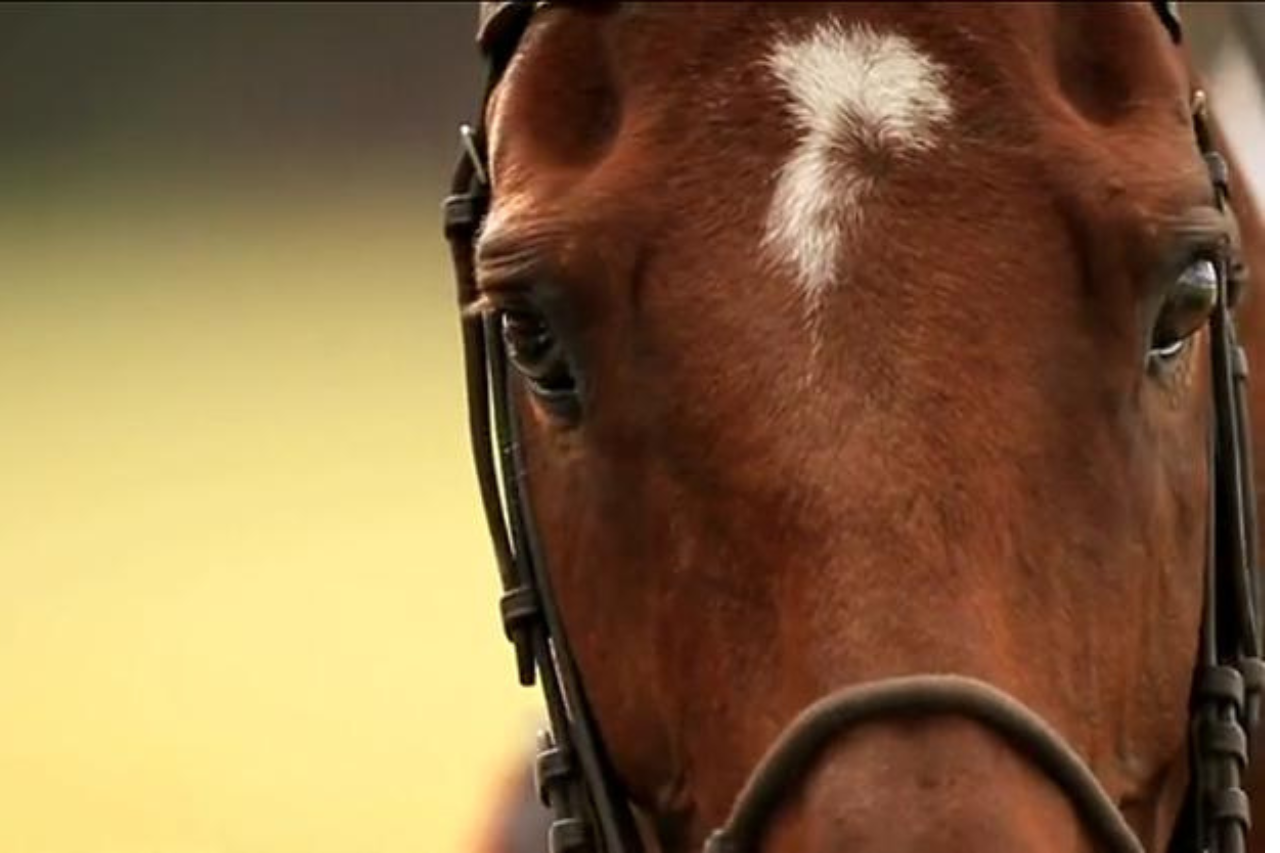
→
(762, 716, 1094, 853)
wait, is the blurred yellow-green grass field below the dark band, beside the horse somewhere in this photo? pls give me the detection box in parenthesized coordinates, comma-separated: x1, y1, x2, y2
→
(0, 169, 536, 853)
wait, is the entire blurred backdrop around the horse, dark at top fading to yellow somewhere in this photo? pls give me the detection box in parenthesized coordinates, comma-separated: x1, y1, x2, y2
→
(0, 4, 1262, 853)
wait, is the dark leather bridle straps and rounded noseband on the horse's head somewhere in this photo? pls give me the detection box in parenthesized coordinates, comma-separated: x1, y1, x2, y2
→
(444, 0, 1263, 853)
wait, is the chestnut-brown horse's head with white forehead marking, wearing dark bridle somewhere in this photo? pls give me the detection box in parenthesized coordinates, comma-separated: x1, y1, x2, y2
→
(444, 3, 1263, 853)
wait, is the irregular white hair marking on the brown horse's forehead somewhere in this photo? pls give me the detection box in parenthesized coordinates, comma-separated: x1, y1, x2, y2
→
(764, 20, 951, 320)
